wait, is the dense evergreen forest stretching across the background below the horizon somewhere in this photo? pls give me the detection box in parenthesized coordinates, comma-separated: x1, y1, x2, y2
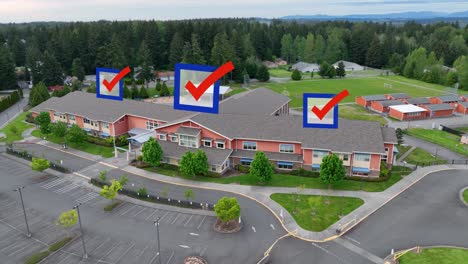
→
(0, 19, 468, 89)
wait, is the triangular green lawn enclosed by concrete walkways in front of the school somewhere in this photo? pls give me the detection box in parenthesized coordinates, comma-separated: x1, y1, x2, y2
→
(270, 193, 364, 232)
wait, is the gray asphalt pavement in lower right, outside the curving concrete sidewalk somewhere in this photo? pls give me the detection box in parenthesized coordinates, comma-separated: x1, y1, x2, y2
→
(347, 170, 468, 258)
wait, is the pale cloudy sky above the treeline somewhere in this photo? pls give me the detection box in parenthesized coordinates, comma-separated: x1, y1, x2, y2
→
(0, 0, 468, 23)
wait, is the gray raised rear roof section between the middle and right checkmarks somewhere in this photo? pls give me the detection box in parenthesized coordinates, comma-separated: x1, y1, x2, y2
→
(219, 88, 291, 115)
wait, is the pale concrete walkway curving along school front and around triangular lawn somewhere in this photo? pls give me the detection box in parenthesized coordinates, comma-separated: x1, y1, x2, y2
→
(17, 141, 468, 242)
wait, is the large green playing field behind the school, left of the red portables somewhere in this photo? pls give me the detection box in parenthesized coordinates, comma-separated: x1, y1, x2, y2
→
(263, 77, 445, 107)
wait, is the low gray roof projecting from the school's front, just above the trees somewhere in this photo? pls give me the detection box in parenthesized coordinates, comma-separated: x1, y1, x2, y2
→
(158, 140, 232, 165)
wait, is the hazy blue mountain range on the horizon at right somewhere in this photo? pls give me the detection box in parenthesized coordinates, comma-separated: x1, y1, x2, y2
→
(280, 11, 468, 21)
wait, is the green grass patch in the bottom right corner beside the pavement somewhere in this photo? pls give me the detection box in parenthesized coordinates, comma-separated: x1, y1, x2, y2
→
(399, 248, 468, 264)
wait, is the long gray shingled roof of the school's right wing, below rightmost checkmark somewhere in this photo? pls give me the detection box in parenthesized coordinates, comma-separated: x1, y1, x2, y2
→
(191, 114, 386, 153)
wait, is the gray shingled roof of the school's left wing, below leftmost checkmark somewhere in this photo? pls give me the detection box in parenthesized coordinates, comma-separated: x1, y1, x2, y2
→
(30, 91, 193, 122)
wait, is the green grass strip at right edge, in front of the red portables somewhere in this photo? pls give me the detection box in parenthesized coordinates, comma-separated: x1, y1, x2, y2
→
(408, 128, 468, 157)
